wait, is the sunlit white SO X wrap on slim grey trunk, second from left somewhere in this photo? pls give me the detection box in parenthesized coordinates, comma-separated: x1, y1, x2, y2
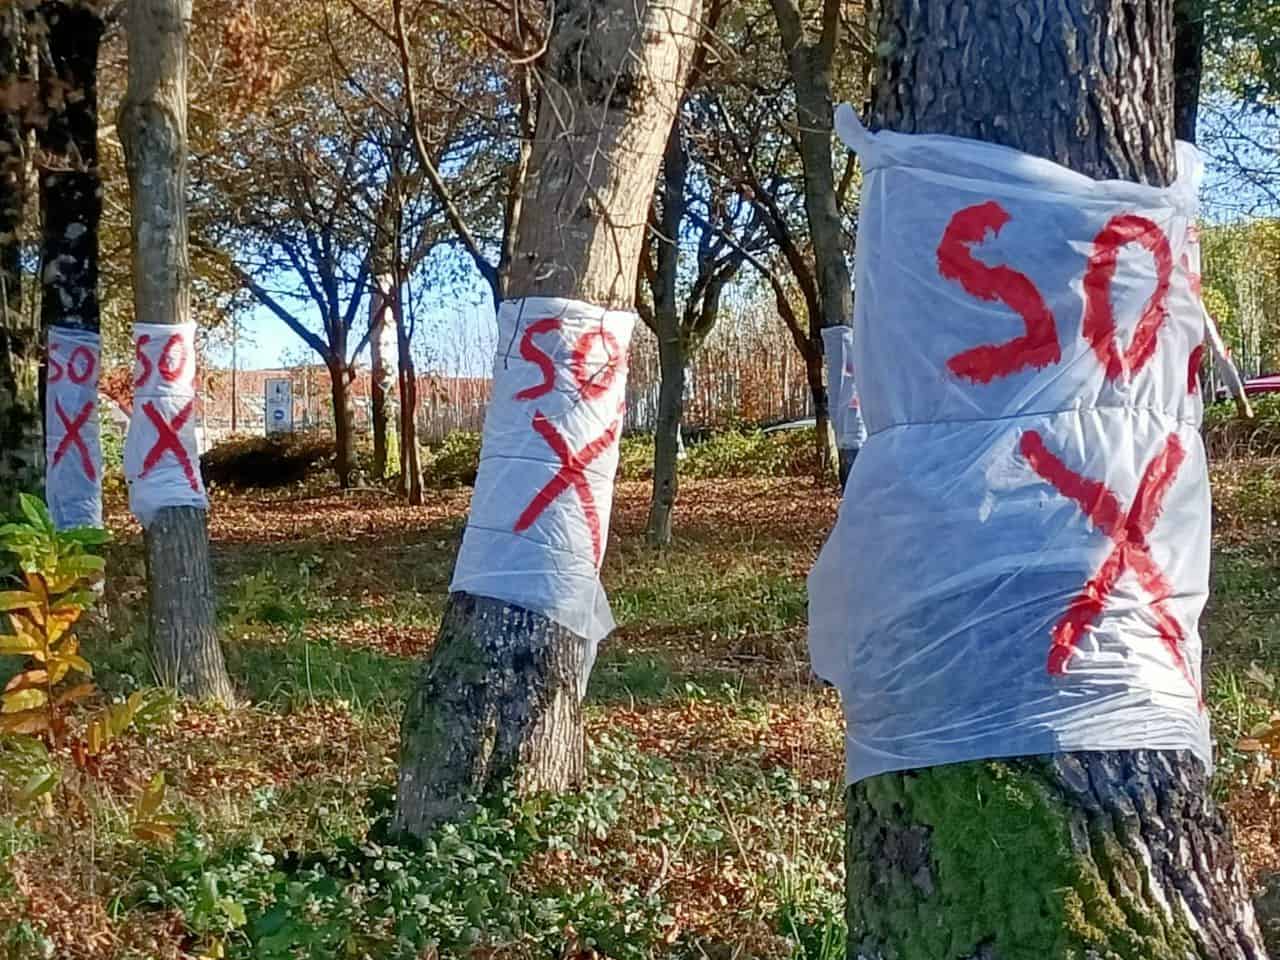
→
(124, 324, 209, 526)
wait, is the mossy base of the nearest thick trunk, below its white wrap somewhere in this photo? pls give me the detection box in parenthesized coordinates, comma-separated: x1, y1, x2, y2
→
(847, 751, 1266, 960)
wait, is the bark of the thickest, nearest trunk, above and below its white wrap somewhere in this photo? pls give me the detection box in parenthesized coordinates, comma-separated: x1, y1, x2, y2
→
(847, 0, 1266, 960)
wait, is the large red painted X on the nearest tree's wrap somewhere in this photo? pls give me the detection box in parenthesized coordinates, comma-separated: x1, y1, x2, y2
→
(1020, 430, 1203, 707)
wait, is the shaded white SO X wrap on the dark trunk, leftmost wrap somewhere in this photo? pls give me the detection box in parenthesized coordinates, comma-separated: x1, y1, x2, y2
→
(45, 326, 102, 530)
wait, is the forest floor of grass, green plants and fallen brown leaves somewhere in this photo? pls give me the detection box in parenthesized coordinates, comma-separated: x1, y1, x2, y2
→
(0, 461, 1280, 960)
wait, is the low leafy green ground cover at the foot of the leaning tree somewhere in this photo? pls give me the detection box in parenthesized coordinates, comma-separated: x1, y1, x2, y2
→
(125, 742, 691, 960)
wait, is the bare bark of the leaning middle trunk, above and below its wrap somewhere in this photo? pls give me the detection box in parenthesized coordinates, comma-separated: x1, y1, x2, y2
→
(397, 0, 700, 835)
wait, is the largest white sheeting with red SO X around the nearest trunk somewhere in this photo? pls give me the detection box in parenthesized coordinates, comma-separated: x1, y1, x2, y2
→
(809, 108, 1211, 781)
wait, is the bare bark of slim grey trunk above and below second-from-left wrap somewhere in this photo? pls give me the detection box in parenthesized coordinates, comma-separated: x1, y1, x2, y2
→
(119, 0, 232, 703)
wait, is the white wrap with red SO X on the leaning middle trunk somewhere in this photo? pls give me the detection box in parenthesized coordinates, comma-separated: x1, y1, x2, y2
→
(449, 297, 635, 644)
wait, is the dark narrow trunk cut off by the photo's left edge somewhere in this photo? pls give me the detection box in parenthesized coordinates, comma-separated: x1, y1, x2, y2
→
(0, 4, 45, 515)
